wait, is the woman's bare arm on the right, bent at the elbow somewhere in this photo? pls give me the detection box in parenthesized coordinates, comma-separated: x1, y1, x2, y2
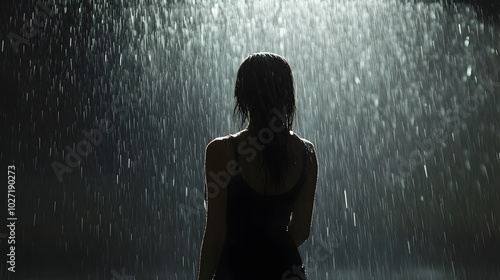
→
(288, 141, 318, 247)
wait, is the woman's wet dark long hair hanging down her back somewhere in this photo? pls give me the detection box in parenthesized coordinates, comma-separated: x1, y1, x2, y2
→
(233, 52, 296, 190)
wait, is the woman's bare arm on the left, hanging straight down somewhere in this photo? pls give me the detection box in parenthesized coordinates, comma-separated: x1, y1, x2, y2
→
(197, 139, 229, 280)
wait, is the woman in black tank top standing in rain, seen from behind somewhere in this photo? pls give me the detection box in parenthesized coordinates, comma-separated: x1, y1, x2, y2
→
(198, 53, 318, 280)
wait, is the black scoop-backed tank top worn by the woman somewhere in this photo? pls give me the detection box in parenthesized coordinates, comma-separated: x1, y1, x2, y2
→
(214, 137, 307, 280)
